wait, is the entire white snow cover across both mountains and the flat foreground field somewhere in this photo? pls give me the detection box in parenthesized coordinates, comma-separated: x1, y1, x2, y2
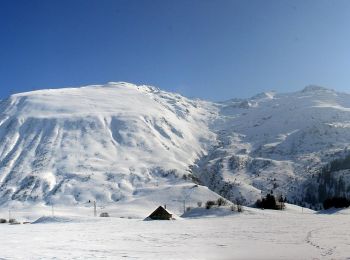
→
(0, 83, 350, 259)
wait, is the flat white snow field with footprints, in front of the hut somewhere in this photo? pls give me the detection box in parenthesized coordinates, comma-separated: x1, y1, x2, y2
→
(0, 206, 350, 259)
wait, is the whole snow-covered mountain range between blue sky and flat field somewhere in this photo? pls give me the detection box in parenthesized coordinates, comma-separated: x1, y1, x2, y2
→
(0, 83, 350, 208)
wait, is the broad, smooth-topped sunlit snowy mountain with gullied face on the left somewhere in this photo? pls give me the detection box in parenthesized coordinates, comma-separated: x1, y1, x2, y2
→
(0, 83, 217, 204)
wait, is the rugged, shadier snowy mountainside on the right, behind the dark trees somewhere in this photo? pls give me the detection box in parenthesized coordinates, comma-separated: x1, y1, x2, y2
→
(195, 86, 350, 204)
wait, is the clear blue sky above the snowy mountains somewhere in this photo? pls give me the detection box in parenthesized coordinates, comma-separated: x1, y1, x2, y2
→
(0, 0, 350, 100)
